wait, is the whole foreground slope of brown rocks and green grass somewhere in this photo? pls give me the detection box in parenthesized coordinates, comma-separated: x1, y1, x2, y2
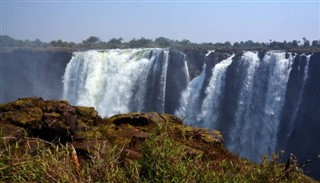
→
(0, 97, 313, 182)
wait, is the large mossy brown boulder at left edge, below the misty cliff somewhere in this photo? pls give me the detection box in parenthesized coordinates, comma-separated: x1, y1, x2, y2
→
(0, 97, 94, 143)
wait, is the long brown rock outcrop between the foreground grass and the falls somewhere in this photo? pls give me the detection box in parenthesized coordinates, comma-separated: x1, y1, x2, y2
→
(0, 97, 225, 161)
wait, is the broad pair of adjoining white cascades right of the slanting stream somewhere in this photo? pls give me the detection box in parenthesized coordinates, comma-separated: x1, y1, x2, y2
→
(228, 51, 293, 161)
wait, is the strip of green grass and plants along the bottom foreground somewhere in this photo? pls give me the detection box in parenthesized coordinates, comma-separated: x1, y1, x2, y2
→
(0, 129, 312, 182)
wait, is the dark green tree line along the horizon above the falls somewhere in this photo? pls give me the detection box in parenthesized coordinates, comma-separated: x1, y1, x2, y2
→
(0, 35, 320, 50)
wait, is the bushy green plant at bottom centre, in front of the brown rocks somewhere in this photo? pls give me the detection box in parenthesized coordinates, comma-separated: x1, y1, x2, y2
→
(140, 134, 215, 182)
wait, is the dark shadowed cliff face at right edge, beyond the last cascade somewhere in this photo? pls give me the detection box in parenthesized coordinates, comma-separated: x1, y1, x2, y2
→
(279, 53, 320, 179)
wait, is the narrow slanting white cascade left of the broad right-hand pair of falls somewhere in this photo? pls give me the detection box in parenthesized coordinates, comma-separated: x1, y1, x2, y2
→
(197, 55, 234, 128)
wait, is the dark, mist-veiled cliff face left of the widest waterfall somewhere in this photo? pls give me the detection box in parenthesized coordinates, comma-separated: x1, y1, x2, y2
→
(0, 49, 72, 103)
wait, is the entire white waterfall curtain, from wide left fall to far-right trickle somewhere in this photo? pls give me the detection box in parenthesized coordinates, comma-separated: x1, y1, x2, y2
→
(63, 48, 318, 169)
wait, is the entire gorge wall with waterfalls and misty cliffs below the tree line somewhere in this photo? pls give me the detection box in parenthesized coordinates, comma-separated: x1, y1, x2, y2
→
(0, 48, 320, 179)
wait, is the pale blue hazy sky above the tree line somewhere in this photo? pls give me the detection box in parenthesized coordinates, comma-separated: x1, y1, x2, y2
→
(0, 0, 320, 43)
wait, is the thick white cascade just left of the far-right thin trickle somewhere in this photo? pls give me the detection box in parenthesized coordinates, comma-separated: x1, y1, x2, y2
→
(260, 52, 293, 153)
